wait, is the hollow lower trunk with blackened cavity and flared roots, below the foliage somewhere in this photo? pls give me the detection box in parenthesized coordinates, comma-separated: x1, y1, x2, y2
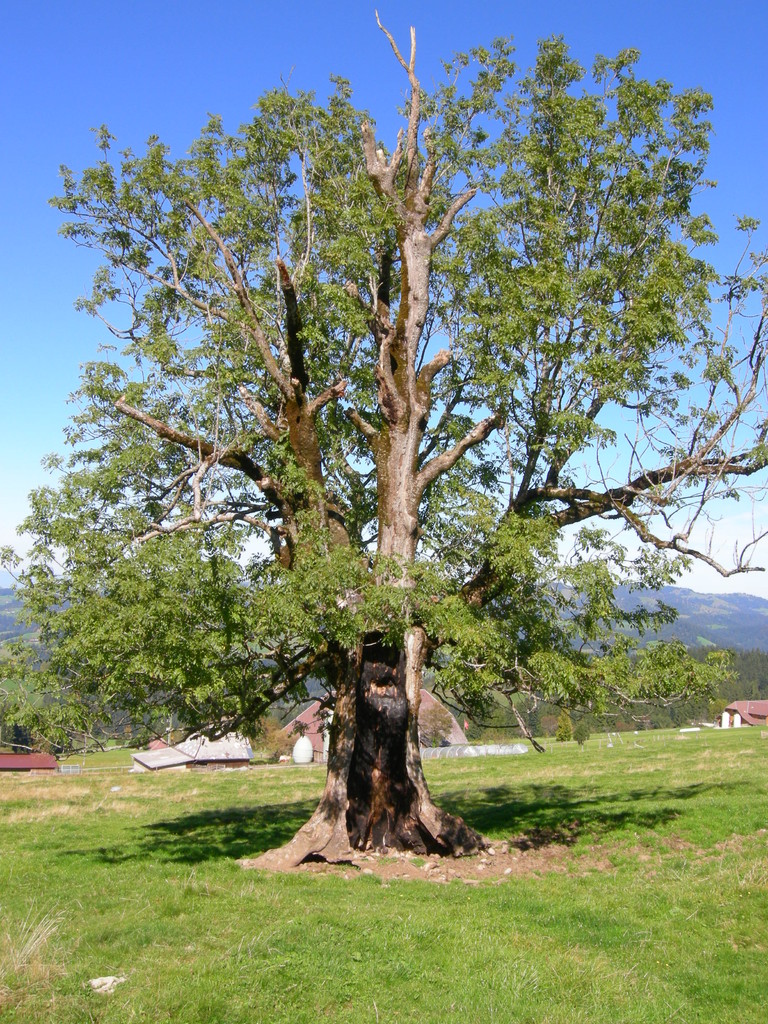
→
(248, 629, 485, 869)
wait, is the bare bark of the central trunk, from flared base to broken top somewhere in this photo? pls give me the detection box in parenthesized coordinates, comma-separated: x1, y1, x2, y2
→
(243, 41, 489, 868)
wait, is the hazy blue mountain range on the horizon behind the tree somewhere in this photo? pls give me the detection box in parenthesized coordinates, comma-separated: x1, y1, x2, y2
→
(0, 587, 768, 651)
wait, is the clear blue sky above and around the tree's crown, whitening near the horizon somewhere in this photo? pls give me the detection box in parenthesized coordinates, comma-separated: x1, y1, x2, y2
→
(0, 0, 768, 596)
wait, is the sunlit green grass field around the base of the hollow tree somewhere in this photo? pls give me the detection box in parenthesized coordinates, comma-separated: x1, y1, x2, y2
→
(0, 729, 768, 1024)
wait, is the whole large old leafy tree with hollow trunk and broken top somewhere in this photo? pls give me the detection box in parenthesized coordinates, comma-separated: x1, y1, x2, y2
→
(3, 22, 767, 864)
